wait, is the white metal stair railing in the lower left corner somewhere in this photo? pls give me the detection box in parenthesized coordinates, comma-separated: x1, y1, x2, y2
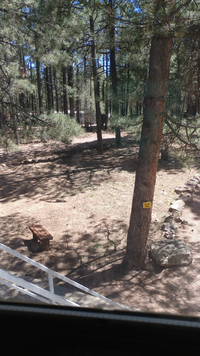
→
(0, 243, 130, 309)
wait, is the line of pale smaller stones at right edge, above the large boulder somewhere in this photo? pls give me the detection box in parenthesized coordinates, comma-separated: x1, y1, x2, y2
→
(162, 174, 200, 239)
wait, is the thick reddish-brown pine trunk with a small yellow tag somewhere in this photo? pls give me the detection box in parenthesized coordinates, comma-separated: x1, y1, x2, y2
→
(124, 35, 172, 269)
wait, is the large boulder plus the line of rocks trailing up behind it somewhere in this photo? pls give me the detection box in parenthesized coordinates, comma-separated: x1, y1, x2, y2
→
(150, 175, 200, 267)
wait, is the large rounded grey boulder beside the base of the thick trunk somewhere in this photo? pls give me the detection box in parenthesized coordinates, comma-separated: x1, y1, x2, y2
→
(151, 240, 192, 267)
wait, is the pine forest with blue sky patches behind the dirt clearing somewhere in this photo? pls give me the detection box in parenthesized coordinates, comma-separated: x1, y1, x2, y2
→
(0, 0, 200, 150)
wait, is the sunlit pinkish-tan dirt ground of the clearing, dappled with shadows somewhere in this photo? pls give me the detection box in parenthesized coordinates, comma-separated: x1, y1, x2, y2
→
(0, 132, 200, 316)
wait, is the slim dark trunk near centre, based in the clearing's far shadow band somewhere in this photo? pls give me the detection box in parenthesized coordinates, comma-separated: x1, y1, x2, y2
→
(90, 16, 103, 154)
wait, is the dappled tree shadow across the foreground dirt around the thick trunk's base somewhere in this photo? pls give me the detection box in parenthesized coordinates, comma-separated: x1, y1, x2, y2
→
(0, 214, 200, 316)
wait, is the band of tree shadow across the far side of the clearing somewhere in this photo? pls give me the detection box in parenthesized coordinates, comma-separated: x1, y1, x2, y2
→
(0, 135, 195, 203)
